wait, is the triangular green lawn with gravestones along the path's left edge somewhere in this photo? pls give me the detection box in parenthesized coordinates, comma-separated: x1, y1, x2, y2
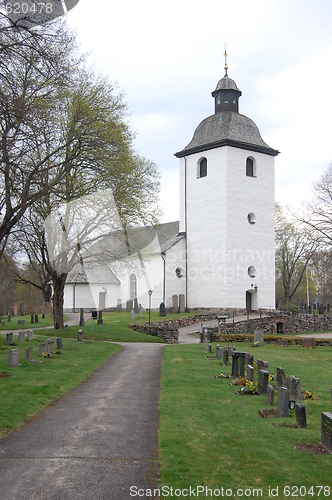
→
(0, 335, 122, 436)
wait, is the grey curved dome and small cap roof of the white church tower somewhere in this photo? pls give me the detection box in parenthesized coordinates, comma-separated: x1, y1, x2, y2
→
(175, 111, 279, 158)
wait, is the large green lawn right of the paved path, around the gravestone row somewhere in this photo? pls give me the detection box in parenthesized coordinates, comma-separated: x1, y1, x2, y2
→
(159, 343, 332, 499)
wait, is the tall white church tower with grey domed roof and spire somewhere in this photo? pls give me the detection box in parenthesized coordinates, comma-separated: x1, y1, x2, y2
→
(175, 51, 279, 310)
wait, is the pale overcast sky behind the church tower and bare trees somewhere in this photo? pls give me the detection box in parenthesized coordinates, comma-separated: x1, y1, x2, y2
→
(69, 0, 332, 222)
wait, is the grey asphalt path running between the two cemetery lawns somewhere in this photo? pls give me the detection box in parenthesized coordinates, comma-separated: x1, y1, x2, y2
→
(0, 343, 164, 500)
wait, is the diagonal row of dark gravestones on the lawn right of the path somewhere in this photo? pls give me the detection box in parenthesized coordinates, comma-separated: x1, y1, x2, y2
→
(214, 344, 332, 453)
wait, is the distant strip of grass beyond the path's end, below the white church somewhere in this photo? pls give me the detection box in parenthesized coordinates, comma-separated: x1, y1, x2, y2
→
(35, 311, 197, 343)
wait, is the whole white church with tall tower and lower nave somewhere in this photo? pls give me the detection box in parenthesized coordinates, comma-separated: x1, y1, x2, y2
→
(64, 64, 279, 310)
